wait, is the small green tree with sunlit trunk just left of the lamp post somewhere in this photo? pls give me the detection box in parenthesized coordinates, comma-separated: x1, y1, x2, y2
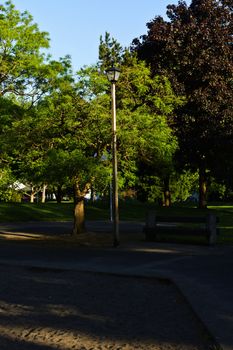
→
(42, 90, 111, 235)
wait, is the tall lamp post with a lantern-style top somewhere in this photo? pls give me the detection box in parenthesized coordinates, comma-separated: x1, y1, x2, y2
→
(106, 67, 120, 247)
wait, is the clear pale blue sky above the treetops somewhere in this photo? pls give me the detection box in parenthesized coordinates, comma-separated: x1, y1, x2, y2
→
(13, 0, 189, 70)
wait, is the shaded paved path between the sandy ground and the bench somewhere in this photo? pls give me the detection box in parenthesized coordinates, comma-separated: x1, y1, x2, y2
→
(0, 221, 233, 350)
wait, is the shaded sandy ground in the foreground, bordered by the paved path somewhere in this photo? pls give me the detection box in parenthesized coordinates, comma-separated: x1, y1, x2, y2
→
(0, 265, 215, 350)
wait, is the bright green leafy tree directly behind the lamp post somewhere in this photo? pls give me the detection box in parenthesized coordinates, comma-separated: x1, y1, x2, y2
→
(74, 41, 183, 216)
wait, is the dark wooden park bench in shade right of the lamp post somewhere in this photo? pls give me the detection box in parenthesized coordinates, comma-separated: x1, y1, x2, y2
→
(143, 210, 218, 245)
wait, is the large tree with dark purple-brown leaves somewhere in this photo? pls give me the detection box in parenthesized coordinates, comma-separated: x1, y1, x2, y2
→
(133, 0, 233, 207)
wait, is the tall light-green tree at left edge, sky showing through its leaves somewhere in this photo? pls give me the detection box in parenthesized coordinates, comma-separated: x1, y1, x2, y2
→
(0, 1, 74, 198)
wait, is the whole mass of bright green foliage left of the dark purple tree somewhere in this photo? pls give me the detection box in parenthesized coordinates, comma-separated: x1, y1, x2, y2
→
(0, 2, 189, 231)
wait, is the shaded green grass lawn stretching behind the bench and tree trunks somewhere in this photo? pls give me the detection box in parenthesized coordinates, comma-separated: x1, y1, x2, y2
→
(0, 200, 233, 244)
